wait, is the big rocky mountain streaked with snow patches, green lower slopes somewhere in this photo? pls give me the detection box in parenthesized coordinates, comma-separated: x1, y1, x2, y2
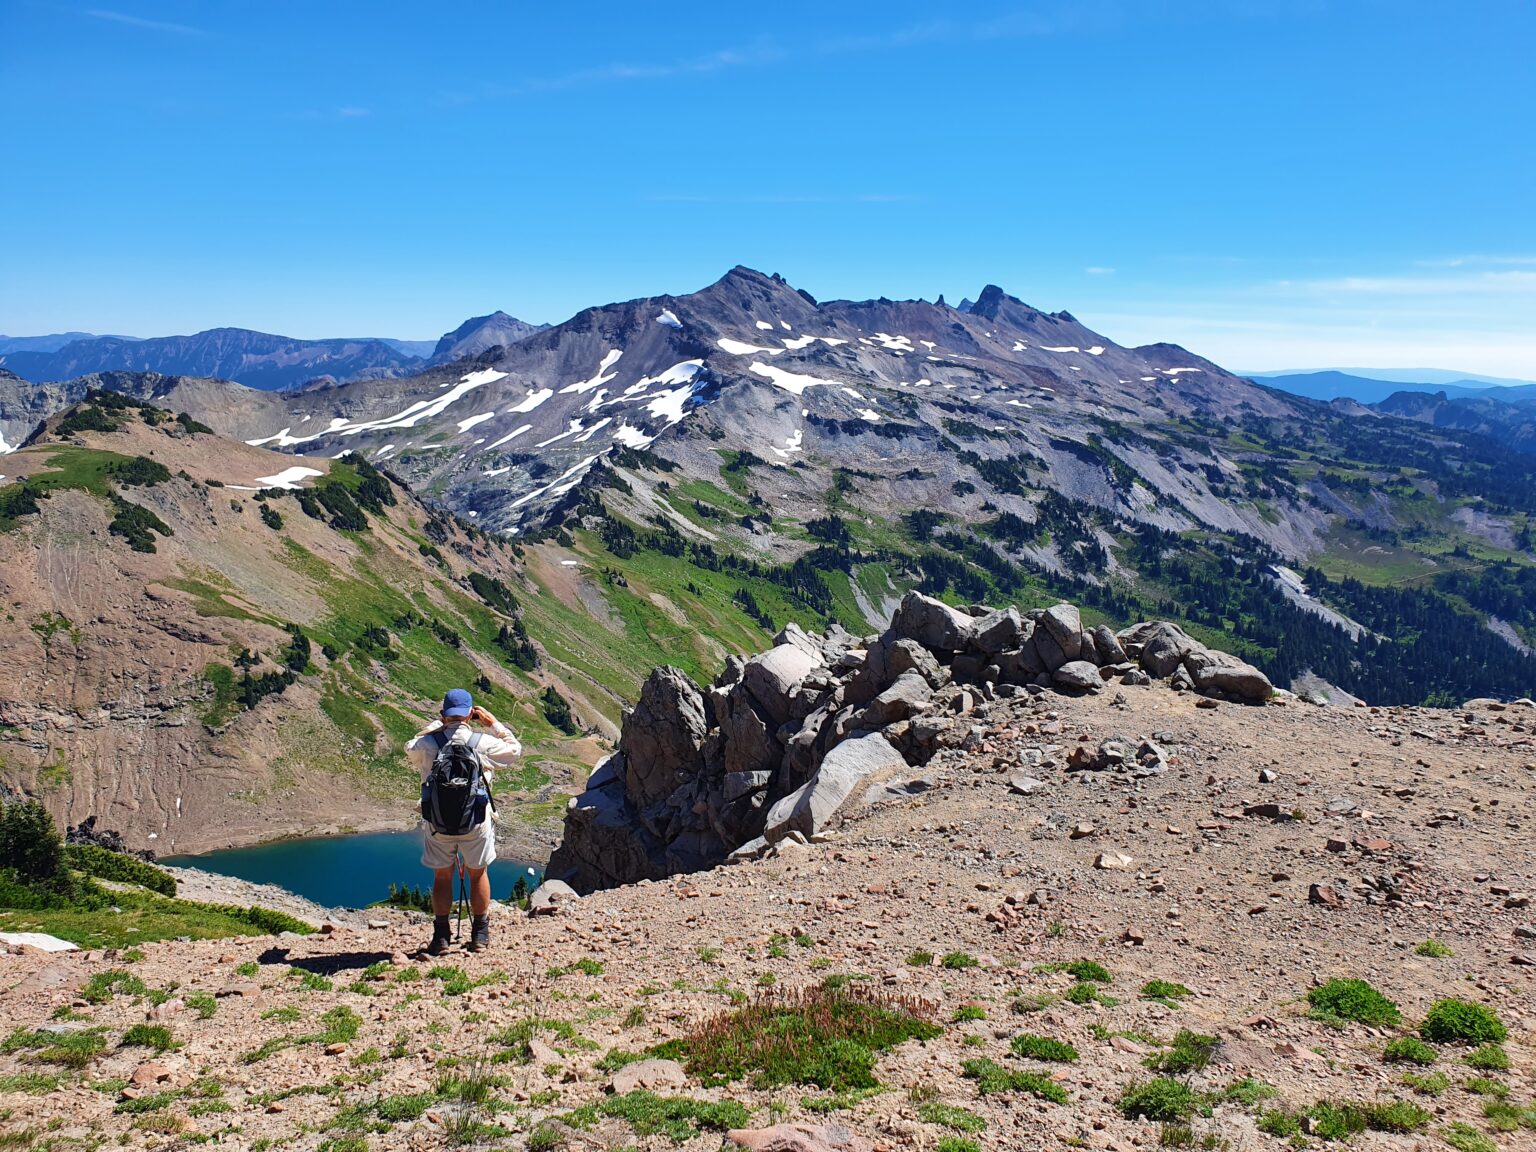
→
(12, 269, 1536, 719)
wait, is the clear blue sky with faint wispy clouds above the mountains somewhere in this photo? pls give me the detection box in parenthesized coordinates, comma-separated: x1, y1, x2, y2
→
(0, 0, 1536, 378)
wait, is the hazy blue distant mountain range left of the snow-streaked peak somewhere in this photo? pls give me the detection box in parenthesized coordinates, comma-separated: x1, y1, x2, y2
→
(0, 312, 541, 392)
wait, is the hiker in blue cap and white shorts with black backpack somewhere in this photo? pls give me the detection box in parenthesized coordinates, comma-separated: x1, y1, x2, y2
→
(406, 688, 522, 955)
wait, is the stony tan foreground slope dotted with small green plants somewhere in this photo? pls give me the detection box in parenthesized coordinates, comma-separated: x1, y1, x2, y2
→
(0, 657, 1536, 1152)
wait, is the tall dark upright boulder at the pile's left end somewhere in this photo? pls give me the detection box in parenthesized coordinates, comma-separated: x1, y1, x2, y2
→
(619, 666, 706, 808)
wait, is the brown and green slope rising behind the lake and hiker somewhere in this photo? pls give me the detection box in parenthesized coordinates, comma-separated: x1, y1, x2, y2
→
(0, 393, 604, 854)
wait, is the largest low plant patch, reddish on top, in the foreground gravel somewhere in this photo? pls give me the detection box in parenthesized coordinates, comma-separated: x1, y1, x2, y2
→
(653, 985, 943, 1092)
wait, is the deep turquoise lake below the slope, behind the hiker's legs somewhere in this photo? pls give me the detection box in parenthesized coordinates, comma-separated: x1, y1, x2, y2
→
(160, 833, 544, 908)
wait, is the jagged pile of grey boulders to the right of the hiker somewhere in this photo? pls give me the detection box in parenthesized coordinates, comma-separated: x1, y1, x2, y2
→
(548, 591, 1273, 891)
